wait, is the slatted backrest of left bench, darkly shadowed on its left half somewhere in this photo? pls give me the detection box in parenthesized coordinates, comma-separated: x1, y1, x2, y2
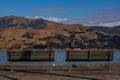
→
(7, 50, 54, 61)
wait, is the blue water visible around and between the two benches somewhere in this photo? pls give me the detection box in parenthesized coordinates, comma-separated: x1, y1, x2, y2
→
(0, 50, 120, 64)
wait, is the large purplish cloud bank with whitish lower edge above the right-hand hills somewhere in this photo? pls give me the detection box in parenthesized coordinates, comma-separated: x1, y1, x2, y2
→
(60, 8, 120, 27)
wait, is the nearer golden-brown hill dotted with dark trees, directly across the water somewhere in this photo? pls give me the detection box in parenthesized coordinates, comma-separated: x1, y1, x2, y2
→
(0, 26, 120, 49)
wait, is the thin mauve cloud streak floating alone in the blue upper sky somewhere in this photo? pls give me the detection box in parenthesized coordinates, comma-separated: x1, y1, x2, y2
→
(32, 6, 82, 14)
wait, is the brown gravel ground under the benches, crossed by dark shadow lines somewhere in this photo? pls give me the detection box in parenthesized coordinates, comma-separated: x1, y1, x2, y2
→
(0, 65, 120, 80)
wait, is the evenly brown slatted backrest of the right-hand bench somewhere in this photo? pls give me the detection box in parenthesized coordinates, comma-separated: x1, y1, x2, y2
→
(66, 50, 114, 61)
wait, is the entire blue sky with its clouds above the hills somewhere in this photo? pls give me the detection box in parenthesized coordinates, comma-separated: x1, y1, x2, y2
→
(0, 0, 120, 27)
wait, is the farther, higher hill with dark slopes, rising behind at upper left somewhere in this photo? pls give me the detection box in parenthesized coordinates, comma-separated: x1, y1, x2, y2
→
(0, 16, 62, 29)
